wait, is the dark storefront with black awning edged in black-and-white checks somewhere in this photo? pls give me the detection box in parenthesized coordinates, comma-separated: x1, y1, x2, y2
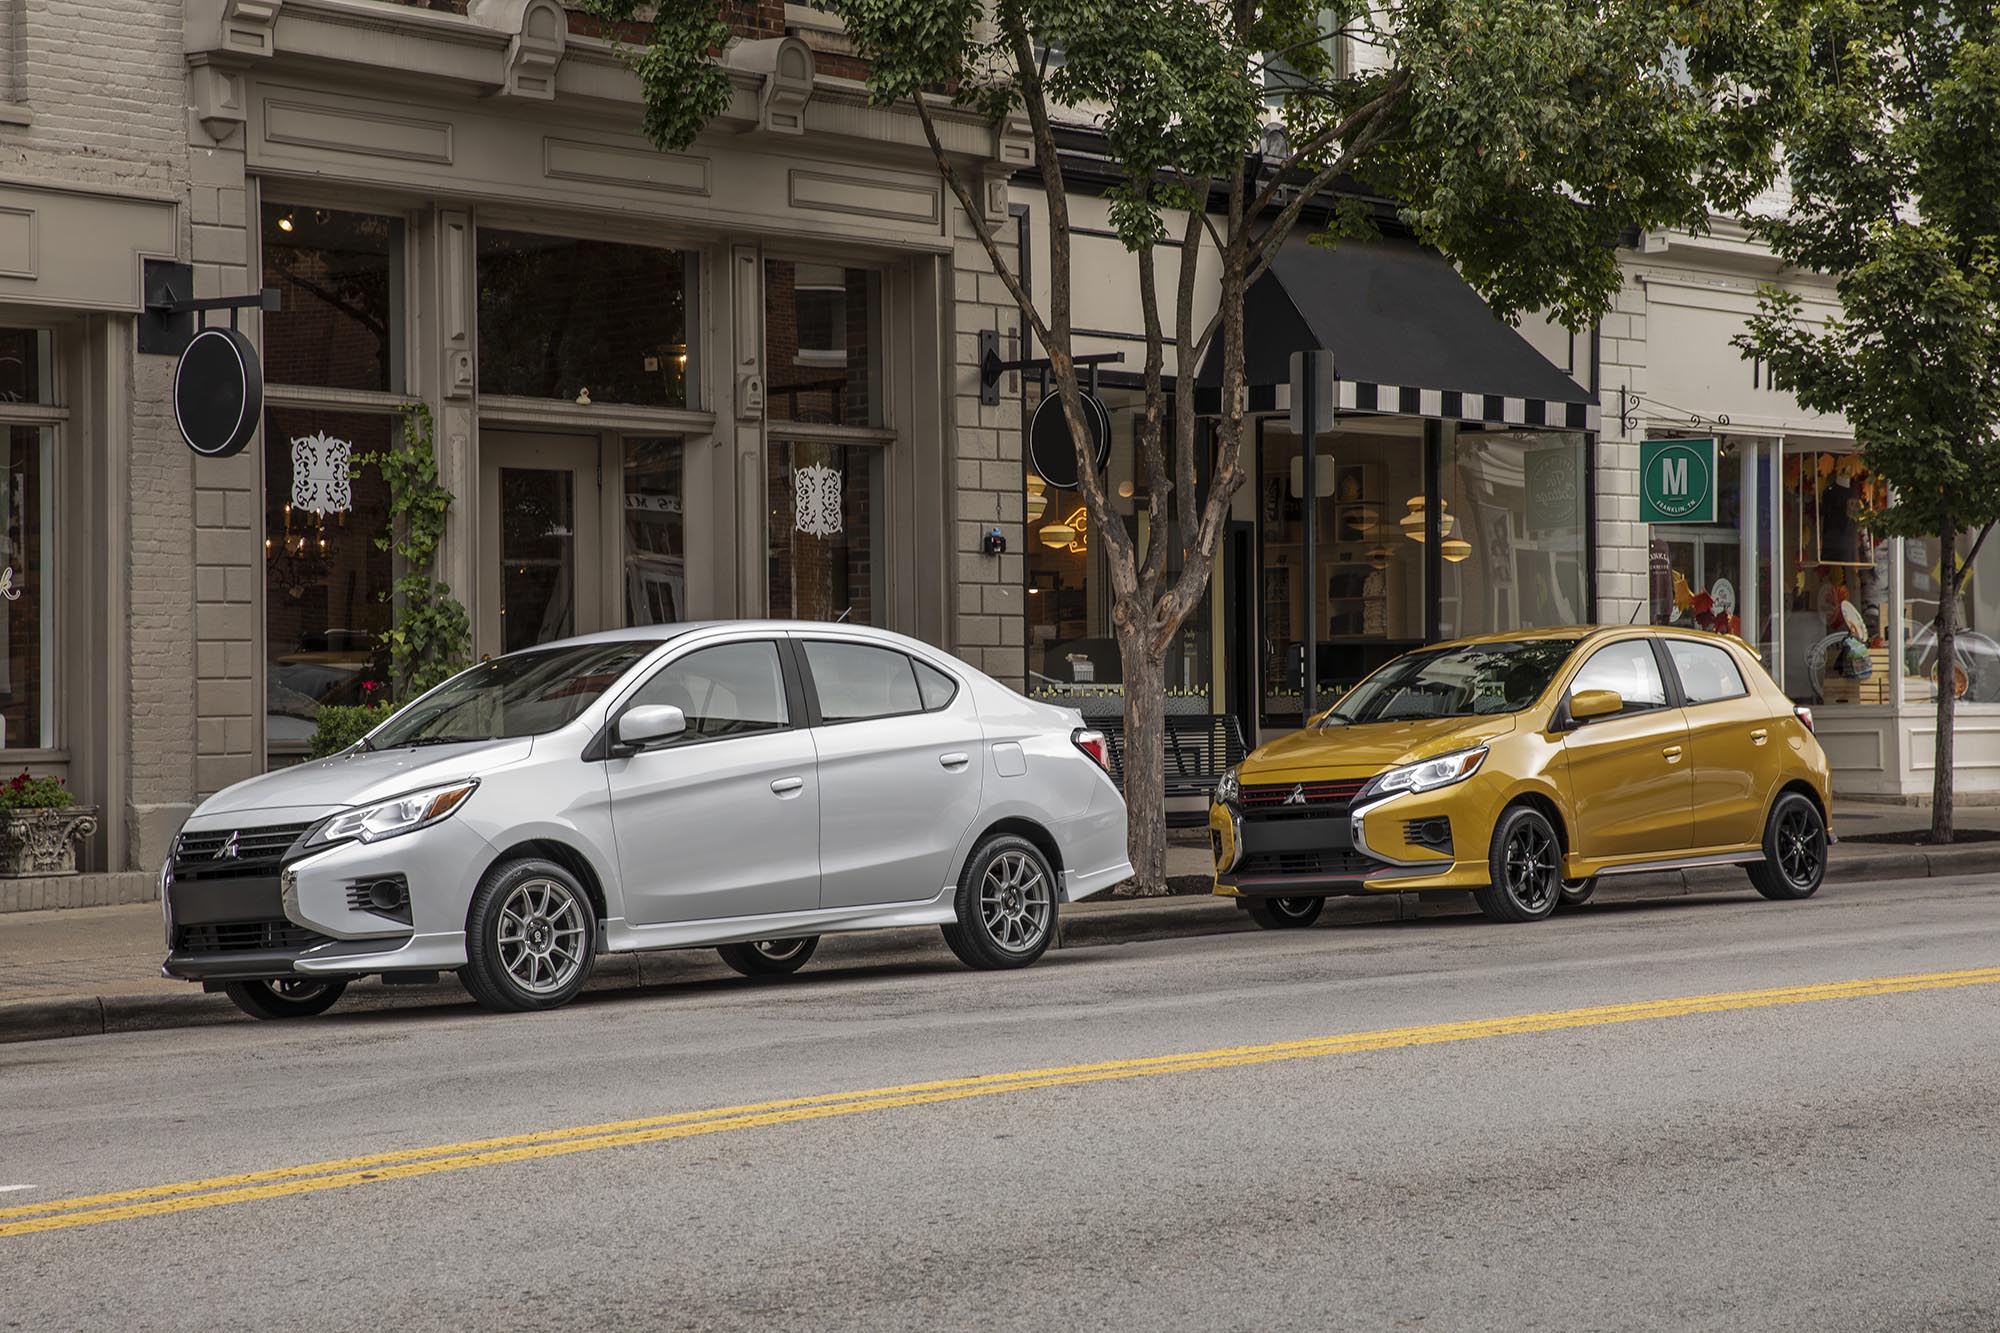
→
(1026, 223, 1596, 743)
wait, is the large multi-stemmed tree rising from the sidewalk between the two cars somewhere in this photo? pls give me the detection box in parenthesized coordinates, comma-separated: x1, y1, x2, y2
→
(584, 0, 1768, 893)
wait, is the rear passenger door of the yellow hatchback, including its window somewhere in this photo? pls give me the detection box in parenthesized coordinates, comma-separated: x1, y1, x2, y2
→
(1662, 638, 1784, 851)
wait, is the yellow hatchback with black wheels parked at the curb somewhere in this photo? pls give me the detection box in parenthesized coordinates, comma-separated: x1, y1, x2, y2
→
(1208, 626, 1832, 929)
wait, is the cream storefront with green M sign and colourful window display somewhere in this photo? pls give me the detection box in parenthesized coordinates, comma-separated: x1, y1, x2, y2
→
(1600, 228, 2000, 799)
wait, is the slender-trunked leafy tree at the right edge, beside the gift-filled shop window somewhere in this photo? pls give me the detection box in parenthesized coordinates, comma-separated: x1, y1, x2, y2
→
(1736, 0, 2000, 843)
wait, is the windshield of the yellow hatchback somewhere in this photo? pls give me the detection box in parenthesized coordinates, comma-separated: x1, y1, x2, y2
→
(1320, 638, 1576, 727)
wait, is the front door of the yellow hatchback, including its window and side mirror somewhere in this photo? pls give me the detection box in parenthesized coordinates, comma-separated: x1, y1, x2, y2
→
(1562, 638, 1694, 859)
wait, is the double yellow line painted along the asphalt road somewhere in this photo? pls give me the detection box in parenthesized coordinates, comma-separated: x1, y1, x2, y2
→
(0, 967, 2000, 1237)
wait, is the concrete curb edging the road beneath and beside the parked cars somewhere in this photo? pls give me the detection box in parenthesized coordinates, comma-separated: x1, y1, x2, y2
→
(0, 843, 2000, 1045)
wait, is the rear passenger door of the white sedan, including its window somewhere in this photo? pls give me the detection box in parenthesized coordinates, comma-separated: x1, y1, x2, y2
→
(798, 636, 982, 907)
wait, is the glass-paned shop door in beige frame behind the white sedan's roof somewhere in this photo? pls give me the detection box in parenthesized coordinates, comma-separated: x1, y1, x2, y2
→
(478, 434, 606, 656)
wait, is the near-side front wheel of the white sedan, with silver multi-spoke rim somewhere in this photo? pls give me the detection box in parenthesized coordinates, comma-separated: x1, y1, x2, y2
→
(458, 857, 598, 1013)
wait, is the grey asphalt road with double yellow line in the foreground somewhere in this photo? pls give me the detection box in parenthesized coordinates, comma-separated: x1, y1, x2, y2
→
(0, 881, 2000, 1329)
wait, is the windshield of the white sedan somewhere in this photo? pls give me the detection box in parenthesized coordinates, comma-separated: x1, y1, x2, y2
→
(366, 638, 664, 751)
